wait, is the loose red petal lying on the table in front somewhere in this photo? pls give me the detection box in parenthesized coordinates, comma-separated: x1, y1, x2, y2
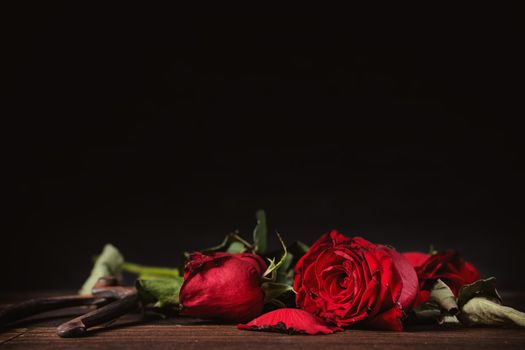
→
(237, 308, 343, 334)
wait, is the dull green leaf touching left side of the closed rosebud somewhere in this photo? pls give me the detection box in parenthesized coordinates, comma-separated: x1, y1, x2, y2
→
(135, 277, 182, 308)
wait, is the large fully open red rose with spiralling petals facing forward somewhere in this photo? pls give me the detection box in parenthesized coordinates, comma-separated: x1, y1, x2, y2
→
(294, 231, 419, 330)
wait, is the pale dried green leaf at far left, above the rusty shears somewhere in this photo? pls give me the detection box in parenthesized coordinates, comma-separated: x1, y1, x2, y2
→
(79, 244, 124, 294)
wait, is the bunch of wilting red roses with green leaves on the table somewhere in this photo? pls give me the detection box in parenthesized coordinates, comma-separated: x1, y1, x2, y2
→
(0, 211, 525, 336)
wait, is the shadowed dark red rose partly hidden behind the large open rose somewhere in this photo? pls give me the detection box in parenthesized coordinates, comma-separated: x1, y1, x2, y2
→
(403, 251, 480, 305)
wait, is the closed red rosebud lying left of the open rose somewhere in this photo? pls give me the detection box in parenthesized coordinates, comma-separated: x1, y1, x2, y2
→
(179, 253, 266, 322)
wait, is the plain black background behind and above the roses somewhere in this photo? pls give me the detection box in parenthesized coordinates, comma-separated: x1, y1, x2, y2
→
(4, 3, 525, 290)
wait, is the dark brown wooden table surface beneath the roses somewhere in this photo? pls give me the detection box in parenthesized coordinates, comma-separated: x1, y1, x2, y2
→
(0, 293, 525, 350)
